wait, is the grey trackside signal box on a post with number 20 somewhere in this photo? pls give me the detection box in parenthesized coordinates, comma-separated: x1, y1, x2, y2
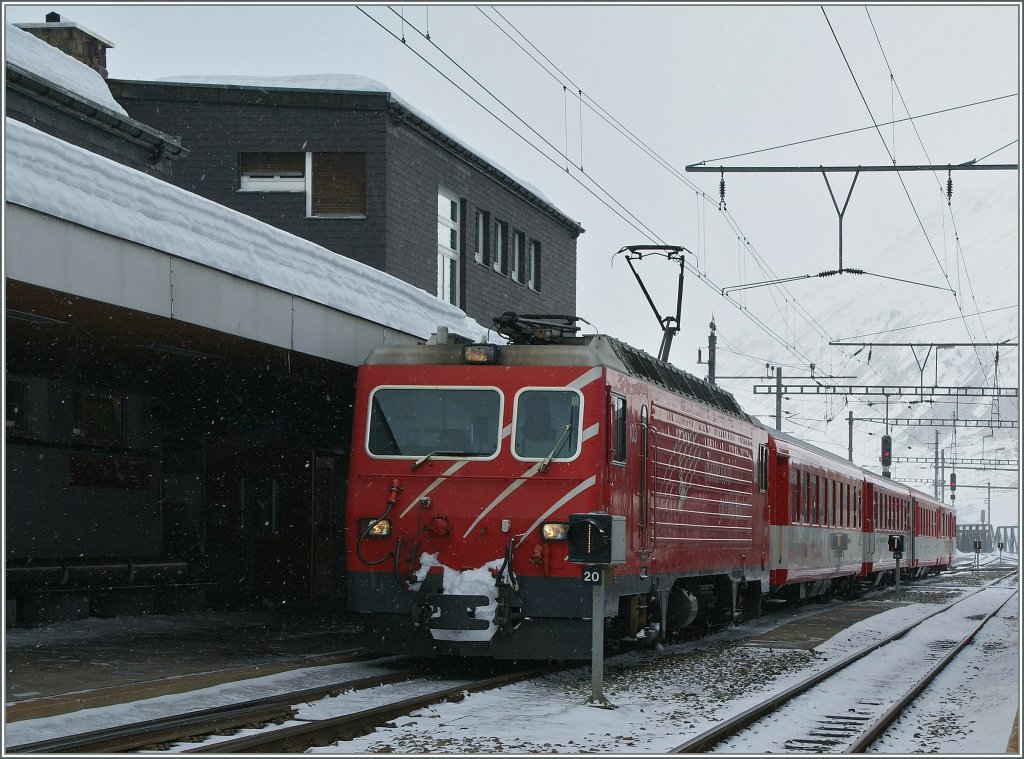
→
(566, 512, 626, 709)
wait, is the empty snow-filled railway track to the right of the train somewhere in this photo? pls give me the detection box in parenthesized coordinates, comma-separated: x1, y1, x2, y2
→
(669, 572, 1019, 754)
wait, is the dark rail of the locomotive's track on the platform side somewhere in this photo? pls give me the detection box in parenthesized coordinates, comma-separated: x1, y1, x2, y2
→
(6, 669, 426, 754)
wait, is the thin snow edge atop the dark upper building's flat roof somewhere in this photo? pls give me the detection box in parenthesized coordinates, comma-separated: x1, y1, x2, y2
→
(152, 74, 582, 231)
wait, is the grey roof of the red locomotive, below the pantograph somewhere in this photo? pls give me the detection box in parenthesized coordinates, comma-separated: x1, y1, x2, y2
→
(366, 335, 750, 421)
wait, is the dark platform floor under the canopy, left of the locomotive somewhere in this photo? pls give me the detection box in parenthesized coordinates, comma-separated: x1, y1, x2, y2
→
(4, 604, 368, 723)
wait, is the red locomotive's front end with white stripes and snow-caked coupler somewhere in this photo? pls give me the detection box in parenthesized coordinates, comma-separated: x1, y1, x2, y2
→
(346, 325, 606, 659)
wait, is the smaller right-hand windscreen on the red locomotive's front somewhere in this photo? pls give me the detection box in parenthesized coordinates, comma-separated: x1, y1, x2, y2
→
(512, 387, 583, 461)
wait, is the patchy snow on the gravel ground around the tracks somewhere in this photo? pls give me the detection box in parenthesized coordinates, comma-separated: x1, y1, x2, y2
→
(5, 573, 1020, 756)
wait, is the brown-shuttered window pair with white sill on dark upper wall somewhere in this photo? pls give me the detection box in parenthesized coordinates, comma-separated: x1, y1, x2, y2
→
(239, 153, 367, 218)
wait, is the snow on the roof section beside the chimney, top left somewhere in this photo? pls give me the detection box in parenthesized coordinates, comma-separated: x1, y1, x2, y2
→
(4, 24, 128, 117)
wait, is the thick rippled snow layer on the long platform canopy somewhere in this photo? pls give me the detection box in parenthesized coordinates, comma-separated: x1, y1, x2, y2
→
(4, 116, 486, 339)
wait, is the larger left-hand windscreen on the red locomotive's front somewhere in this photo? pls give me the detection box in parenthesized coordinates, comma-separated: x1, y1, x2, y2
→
(367, 387, 502, 458)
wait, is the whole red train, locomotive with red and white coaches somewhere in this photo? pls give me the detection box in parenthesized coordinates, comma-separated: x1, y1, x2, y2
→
(345, 313, 956, 660)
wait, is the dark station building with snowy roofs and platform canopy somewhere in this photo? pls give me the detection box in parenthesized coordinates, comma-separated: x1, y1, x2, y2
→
(4, 14, 582, 625)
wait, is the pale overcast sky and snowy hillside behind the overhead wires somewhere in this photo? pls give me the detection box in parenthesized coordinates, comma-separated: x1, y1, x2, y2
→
(4, 3, 1021, 524)
